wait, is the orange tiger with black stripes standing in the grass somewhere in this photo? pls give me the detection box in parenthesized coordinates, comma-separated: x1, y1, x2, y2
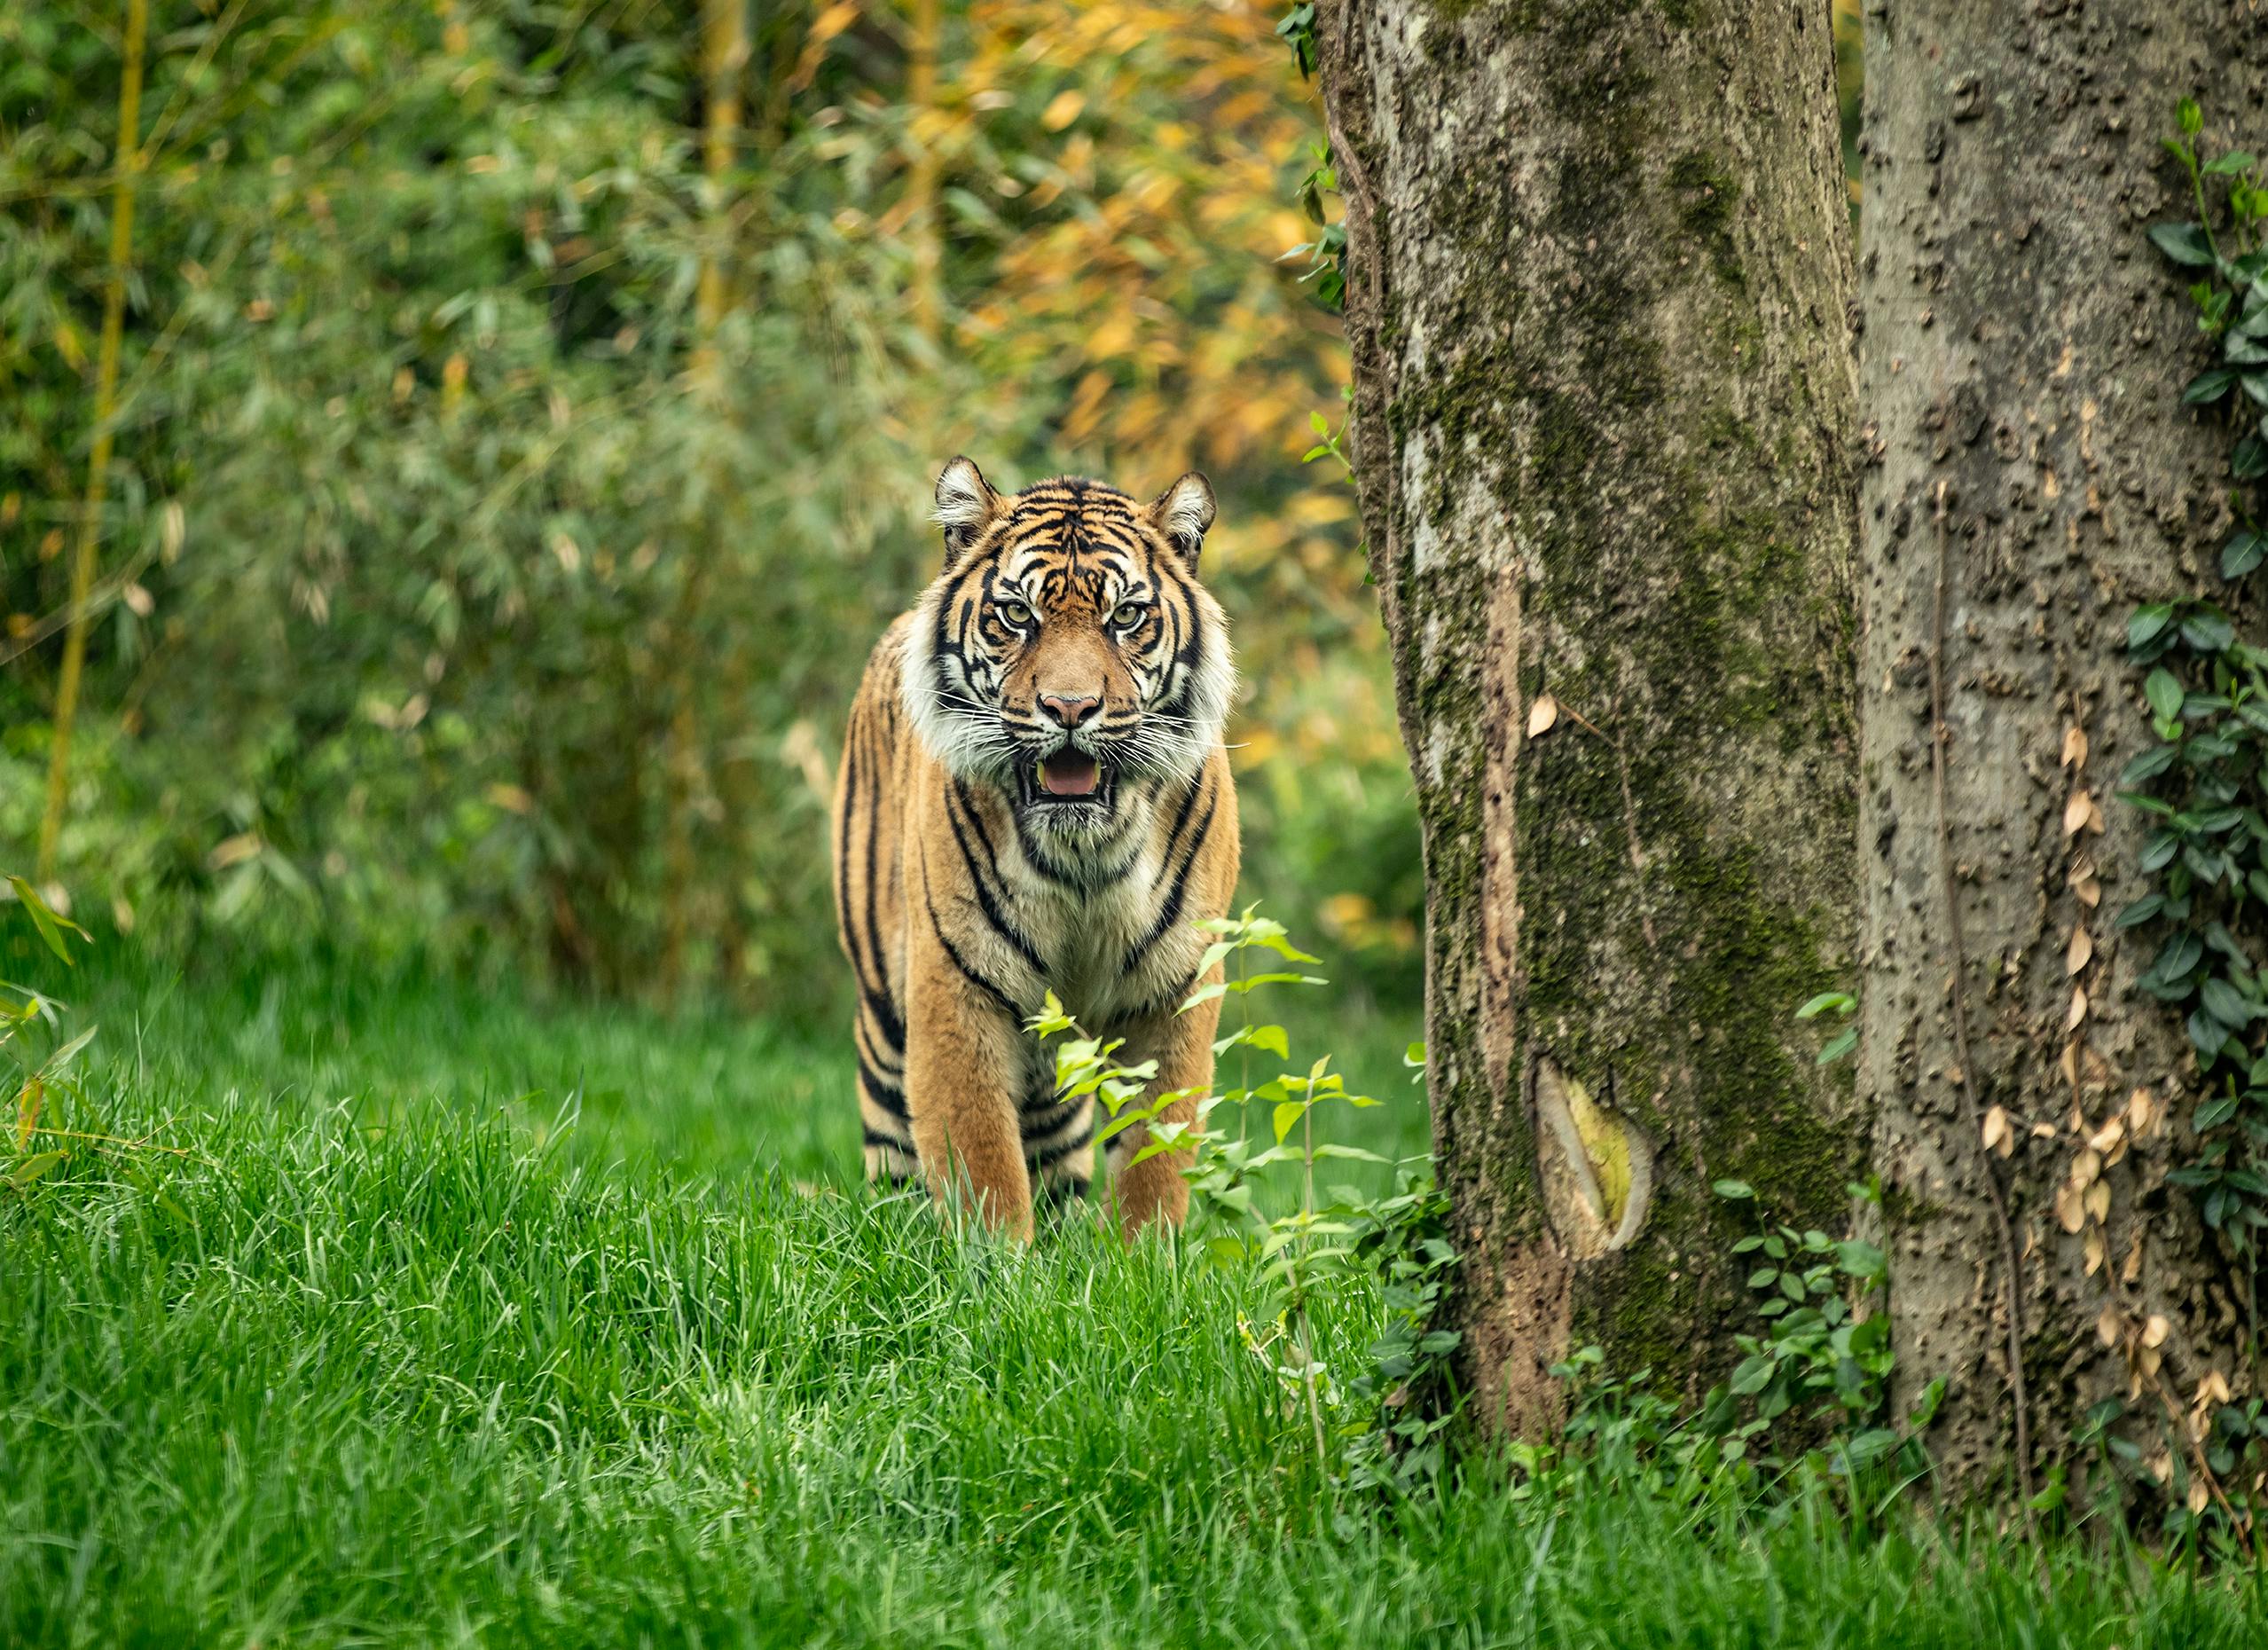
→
(832, 456, 1238, 1241)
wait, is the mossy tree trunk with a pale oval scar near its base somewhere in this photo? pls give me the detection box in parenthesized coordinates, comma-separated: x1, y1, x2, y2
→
(1320, 0, 1864, 1432)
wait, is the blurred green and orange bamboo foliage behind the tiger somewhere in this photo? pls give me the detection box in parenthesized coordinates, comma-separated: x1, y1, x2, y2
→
(0, 0, 1420, 1015)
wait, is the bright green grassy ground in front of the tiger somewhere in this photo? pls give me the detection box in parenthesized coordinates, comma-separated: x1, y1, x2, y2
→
(0, 948, 2264, 1650)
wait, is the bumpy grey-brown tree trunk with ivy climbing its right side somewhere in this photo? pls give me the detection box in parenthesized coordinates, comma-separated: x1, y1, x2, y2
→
(1860, 0, 2268, 1487)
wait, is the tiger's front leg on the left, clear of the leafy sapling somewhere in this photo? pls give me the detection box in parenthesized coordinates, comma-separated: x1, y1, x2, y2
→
(905, 906, 1032, 1241)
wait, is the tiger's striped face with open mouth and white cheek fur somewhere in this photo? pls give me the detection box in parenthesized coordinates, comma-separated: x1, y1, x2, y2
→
(903, 459, 1234, 833)
